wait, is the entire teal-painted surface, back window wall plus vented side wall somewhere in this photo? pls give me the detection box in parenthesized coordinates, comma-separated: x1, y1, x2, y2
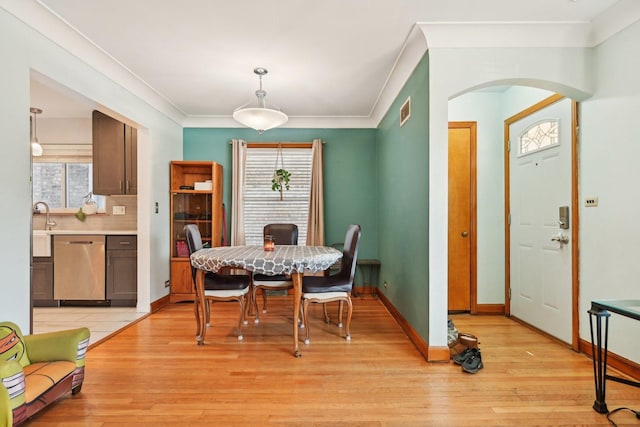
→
(183, 54, 429, 342)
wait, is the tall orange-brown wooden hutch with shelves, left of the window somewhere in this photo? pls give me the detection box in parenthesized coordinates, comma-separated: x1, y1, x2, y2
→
(169, 161, 222, 303)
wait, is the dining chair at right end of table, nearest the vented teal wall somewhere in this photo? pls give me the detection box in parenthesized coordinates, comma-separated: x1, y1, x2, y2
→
(302, 224, 362, 344)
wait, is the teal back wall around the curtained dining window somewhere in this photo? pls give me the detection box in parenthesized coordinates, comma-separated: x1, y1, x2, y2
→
(183, 128, 379, 258)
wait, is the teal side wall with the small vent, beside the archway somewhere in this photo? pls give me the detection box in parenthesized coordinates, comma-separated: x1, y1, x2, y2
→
(377, 54, 429, 342)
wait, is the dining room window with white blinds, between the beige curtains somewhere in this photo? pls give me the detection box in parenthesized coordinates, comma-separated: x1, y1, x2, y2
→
(244, 144, 312, 245)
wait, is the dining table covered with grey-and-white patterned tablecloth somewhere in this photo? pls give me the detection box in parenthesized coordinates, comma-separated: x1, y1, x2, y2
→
(191, 245, 342, 357)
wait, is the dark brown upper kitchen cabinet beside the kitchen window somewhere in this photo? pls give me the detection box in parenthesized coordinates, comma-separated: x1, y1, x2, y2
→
(93, 110, 138, 195)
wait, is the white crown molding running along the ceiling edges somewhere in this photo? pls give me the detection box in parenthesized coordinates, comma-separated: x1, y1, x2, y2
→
(5, 0, 640, 128)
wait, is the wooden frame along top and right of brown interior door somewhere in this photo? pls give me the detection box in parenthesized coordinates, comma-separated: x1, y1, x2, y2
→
(448, 121, 478, 314)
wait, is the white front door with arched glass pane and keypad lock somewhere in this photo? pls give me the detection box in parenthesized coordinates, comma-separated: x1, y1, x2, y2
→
(509, 99, 573, 343)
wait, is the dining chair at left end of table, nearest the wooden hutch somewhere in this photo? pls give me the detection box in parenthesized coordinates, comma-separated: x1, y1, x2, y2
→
(184, 224, 251, 345)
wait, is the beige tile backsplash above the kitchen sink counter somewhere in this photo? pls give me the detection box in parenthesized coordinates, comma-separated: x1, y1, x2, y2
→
(33, 196, 138, 231)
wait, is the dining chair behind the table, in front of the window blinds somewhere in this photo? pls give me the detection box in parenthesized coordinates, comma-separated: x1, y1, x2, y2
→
(251, 224, 298, 323)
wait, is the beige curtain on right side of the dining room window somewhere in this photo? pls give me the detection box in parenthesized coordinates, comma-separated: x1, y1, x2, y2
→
(307, 139, 324, 246)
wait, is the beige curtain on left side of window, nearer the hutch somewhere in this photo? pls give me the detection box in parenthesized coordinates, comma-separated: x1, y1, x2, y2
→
(231, 139, 247, 246)
